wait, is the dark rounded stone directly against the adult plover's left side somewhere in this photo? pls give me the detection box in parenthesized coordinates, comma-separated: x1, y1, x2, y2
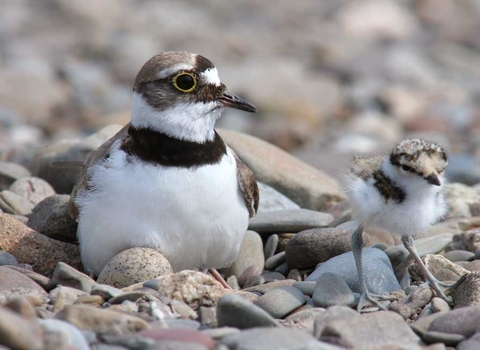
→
(28, 194, 77, 243)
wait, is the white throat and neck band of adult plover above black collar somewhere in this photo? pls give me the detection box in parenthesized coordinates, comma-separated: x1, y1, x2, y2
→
(131, 92, 224, 143)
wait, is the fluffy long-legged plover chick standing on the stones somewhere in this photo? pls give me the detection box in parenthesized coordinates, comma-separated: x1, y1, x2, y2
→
(346, 139, 451, 311)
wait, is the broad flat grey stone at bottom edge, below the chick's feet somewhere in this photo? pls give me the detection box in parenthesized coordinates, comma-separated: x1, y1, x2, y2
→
(321, 311, 421, 349)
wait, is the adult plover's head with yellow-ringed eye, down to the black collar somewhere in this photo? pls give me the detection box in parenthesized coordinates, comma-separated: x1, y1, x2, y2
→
(131, 51, 257, 143)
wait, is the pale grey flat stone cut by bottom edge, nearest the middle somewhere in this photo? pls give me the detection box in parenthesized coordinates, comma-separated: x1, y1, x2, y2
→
(220, 328, 328, 350)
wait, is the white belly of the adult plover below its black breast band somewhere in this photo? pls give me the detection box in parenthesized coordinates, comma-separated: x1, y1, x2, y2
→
(76, 146, 248, 275)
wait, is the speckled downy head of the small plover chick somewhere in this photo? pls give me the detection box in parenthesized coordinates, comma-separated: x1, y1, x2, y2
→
(390, 139, 448, 186)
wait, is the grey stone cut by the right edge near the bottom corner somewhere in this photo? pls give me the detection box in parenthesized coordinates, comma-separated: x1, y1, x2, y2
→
(428, 306, 480, 338)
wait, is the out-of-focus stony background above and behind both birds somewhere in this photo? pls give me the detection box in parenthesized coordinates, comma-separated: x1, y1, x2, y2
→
(0, 0, 480, 185)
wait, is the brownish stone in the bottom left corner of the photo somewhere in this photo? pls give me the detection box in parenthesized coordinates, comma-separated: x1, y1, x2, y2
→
(0, 307, 43, 350)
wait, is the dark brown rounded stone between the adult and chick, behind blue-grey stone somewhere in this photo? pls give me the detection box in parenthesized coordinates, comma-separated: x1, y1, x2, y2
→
(285, 228, 351, 269)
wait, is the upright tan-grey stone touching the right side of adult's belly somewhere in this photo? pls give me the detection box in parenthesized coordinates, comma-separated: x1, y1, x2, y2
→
(223, 231, 265, 285)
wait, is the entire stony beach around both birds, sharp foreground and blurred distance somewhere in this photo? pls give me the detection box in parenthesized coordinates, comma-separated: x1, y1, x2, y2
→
(0, 0, 480, 350)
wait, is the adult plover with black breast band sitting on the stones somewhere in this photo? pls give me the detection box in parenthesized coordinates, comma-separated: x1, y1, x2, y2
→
(70, 52, 258, 275)
